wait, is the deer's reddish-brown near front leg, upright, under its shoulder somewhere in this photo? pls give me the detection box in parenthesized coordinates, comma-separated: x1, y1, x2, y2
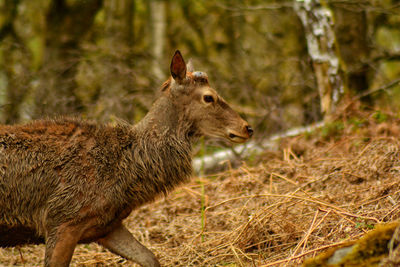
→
(44, 224, 82, 267)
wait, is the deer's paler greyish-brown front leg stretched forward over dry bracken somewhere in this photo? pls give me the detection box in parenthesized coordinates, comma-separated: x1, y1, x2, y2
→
(97, 224, 160, 267)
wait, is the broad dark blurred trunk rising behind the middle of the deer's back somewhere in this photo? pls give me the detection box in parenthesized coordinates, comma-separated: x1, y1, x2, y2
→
(34, 0, 102, 117)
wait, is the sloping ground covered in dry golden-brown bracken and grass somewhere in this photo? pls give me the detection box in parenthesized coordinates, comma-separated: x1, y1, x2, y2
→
(0, 108, 400, 267)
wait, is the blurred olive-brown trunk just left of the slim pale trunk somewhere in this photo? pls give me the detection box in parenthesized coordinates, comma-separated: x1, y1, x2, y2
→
(93, 0, 134, 121)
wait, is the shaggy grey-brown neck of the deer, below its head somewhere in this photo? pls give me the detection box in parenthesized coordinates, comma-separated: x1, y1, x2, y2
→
(122, 96, 192, 207)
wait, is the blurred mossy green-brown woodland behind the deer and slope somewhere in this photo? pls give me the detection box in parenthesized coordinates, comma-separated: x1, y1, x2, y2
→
(0, 0, 400, 141)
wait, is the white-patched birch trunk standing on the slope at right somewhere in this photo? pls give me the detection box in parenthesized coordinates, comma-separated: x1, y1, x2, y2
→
(295, 0, 346, 120)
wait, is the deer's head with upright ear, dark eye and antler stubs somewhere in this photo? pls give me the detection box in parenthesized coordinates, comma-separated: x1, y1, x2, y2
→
(162, 51, 253, 143)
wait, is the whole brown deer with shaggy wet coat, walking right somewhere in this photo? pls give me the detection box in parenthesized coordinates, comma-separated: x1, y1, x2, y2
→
(0, 51, 253, 267)
